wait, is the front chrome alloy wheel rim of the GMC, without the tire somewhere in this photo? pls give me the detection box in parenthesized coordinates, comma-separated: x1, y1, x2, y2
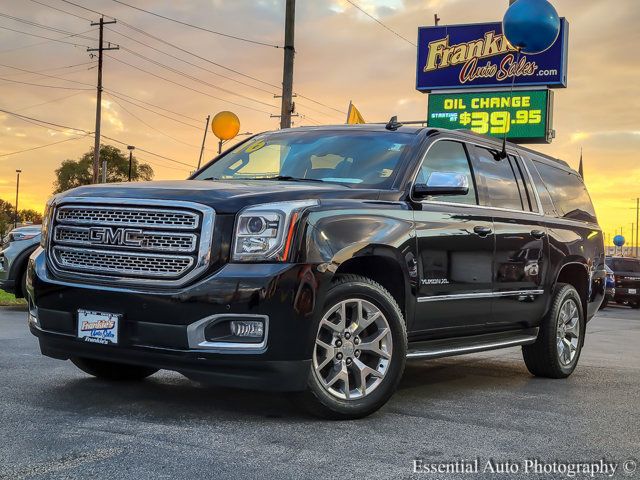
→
(313, 298, 393, 400)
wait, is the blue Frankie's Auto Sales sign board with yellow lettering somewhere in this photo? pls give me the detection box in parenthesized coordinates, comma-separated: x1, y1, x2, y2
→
(416, 18, 569, 92)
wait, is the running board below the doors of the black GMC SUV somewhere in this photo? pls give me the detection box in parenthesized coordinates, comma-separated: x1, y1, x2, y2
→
(407, 327, 538, 359)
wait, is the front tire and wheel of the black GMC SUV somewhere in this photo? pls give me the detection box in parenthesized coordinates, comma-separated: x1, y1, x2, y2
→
(298, 275, 407, 420)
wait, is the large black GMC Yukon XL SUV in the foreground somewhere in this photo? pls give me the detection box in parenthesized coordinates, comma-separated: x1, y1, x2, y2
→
(28, 122, 605, 418)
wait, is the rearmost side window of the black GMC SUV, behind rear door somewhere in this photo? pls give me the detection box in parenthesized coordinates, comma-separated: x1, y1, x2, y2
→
(534, 162, 596, 222)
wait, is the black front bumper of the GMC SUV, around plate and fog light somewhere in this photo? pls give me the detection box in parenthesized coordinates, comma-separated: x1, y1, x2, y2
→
(27, 251, 327, 391)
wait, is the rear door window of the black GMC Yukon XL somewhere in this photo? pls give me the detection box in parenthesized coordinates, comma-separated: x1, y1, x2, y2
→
(476, 148, 528, 210)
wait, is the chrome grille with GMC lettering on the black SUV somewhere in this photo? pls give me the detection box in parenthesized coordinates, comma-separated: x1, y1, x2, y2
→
(48, 199, 214, 285)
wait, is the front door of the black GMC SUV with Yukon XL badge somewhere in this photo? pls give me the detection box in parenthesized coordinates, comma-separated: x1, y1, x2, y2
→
(412, 140, 495, 336)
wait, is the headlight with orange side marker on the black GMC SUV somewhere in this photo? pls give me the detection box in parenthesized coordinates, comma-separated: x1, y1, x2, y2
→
(232, 200, 318, 262)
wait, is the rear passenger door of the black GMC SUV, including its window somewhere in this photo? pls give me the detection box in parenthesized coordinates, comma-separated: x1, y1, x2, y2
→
(474, 146, 549, 329)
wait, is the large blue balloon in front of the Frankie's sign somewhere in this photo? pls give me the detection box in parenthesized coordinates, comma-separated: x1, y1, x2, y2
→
(502, 0, 560, 55)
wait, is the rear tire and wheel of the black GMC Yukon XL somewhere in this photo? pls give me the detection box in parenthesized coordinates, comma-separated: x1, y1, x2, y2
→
(522, 283, 586, 378)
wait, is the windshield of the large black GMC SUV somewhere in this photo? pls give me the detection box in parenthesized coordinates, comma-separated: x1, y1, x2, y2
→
(195, 130, 416, 188)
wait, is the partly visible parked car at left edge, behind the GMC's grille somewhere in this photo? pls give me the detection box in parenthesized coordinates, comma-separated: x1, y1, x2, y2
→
(0, 225, 41, 298)
